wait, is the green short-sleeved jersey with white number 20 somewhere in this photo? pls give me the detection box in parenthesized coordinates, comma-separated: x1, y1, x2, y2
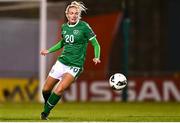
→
(58, 21, 95, 67)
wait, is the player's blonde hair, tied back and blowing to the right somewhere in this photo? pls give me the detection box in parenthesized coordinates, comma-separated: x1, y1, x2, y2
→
(65, 1, 87, 19)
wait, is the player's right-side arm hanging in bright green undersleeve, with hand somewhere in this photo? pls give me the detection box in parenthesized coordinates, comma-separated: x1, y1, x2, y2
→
(90, 36, 101, 65)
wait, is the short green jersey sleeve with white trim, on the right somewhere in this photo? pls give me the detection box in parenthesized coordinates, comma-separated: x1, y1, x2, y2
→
(85, 23, 96, 40)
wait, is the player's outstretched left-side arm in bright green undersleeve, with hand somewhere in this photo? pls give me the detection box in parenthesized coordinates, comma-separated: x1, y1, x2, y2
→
(40, 39, 64, 56)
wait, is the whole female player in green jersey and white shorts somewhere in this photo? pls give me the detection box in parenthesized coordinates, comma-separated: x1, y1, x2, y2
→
(40, 1, 100, 120)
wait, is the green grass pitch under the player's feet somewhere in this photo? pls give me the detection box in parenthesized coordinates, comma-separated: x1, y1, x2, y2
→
(0, 102, 180, 122)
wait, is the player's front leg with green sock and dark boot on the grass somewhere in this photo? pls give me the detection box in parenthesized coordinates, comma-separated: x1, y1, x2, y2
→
(42, 73, 74, 116)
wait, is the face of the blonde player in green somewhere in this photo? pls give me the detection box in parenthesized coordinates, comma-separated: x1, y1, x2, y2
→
(67, 7, 79, 24)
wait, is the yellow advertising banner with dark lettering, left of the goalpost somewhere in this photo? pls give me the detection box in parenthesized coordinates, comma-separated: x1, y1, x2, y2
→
(0, 78, 39, 102)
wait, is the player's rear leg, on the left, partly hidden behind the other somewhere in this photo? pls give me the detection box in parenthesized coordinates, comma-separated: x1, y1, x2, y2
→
(42, 76, 59, 104)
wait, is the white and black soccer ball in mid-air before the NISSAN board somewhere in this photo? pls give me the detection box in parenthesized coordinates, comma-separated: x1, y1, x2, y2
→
(109, 73, 127, 90)
